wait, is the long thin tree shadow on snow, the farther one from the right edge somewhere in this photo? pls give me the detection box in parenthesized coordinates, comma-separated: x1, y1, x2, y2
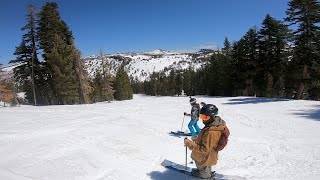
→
(223, 97, 290, 105)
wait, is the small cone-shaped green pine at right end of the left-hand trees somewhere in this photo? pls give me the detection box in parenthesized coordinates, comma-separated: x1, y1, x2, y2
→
(114, 64, 133, 101)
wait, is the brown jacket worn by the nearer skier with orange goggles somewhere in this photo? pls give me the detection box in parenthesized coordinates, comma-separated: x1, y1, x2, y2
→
(188, 117, 226, 166)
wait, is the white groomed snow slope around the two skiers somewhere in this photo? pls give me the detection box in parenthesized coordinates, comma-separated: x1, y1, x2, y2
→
(0, 95, 320, 180)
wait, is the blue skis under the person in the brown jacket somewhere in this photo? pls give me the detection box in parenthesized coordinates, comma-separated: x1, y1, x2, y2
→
(161, 159, 245, 180)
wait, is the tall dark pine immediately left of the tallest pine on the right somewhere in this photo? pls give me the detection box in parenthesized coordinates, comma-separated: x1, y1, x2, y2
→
(256, 14, 288, 97)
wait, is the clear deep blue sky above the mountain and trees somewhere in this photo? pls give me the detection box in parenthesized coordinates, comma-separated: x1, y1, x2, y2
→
(0, 0, 289, 65)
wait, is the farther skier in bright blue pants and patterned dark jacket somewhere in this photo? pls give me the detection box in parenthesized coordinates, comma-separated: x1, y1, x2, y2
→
(183, 97, 201, 136)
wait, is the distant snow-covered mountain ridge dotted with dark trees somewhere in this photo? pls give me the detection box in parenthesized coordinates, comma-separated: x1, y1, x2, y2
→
(85, 49, 212, 81)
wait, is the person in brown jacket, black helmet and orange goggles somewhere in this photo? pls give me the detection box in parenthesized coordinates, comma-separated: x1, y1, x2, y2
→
(184, 104, 229, 179)
